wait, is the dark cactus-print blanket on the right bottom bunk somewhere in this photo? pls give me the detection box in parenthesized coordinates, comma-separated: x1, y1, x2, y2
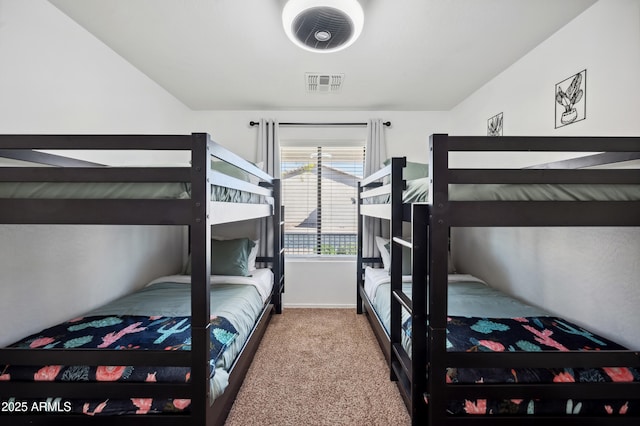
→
(403, 316, 640, 415)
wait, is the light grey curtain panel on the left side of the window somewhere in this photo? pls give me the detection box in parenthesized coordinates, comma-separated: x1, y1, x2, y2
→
(258, 119, 280, 256)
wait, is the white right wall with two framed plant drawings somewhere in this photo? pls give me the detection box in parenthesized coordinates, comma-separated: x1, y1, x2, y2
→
(450, 0, 640, 349)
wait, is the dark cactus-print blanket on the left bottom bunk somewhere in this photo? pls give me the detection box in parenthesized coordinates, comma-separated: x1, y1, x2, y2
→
(0, 315, 238, 415)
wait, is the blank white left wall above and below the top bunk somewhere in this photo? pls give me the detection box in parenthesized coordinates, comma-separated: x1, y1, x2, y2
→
(0, 0, 190, 345)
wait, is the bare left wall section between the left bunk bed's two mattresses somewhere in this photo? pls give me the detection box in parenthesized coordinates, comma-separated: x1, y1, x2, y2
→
(0, 225, 183, 346)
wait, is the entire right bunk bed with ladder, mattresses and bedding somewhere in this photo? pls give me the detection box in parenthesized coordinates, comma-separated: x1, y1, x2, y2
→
(359, 135, 640, 425)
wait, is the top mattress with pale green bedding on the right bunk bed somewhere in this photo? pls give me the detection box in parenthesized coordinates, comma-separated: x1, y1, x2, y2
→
(365, 178, 640, 204)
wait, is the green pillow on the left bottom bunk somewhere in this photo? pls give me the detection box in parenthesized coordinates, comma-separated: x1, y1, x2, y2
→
(184, 238, 257, 277)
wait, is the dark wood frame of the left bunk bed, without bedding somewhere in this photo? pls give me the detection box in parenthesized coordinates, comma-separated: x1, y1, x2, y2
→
(0, 133, 284, 426)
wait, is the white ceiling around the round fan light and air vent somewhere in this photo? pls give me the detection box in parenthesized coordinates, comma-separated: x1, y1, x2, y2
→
(50, 0, 595, 111)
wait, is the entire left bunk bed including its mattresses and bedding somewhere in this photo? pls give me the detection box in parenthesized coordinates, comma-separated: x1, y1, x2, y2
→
(0, 133, 284, 425)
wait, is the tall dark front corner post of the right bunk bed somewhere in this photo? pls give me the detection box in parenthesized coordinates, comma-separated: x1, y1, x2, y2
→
(428, 134, 449, 425)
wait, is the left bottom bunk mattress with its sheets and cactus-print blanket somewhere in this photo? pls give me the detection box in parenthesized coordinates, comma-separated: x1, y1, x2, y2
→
(0, 269, 273, 415)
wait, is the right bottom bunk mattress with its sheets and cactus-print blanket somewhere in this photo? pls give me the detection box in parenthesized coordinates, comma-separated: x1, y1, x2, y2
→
(365, 267, 640, 416)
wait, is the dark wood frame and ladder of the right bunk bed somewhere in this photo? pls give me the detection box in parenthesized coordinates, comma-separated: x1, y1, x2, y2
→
(358, 134, 640, 425)
